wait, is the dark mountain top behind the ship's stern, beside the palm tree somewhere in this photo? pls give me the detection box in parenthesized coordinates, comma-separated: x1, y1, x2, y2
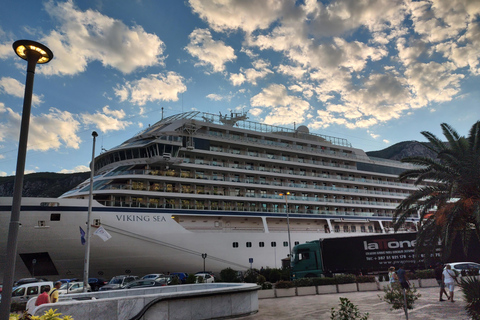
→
(367, 141, 435, 161)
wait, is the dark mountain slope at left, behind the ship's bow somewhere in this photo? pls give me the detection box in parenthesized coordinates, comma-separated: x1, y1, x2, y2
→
(0, 172, 90, 198)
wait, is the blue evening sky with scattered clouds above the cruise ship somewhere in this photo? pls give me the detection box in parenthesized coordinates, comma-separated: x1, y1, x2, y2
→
(0, 0, 480, 176)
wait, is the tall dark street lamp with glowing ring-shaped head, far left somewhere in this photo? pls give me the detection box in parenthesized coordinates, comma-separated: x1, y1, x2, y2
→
(0, 40, 53, 320)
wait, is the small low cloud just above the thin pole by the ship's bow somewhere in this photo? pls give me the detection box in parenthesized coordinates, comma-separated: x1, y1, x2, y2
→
(81, 106, 132, 133)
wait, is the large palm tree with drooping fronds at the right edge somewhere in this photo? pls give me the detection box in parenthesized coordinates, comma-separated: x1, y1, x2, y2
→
(393, 121, 480, 257)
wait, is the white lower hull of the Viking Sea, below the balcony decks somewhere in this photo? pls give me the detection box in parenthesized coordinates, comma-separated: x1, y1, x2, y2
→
(0, 198, 404, 279)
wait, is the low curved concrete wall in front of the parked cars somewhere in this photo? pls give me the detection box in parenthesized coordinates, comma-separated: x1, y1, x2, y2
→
(34, 283, 260, 320)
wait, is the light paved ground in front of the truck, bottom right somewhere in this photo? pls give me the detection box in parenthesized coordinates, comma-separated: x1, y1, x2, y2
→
(241, 288, 469, 320)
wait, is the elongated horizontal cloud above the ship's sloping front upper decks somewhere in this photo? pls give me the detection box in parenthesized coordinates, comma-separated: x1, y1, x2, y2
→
(114, 71, 187, 106)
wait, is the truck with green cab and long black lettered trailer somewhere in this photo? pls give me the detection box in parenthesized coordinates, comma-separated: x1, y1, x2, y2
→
(290, 232, 480, 279)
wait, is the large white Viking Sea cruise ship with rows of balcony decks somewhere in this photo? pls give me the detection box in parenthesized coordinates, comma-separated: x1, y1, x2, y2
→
(0, 111, 418, 278)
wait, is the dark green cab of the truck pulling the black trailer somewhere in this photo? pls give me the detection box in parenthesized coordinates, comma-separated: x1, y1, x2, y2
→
(291, 240, 323, 279)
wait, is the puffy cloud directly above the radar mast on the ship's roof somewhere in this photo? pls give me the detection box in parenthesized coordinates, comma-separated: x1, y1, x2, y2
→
(250, 84, 311, 125)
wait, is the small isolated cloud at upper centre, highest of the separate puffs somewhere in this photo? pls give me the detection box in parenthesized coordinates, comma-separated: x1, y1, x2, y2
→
(185, 29, 237, 72)
